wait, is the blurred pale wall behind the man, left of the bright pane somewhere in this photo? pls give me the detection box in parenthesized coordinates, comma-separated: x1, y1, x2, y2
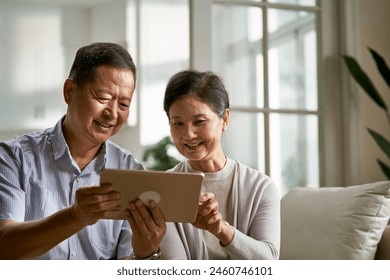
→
(0, 0, 143, 158)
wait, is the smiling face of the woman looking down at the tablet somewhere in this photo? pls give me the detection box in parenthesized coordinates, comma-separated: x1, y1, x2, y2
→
(169, 96, 229, 164)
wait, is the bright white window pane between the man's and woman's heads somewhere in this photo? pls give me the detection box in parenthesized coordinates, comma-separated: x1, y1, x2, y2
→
(139, 0, 189, 145)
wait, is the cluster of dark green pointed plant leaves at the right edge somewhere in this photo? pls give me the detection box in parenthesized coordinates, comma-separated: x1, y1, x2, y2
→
(343, 48, 390, 180)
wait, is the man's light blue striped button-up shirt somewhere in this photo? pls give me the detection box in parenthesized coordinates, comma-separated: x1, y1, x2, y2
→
(0, 117, 144, 259)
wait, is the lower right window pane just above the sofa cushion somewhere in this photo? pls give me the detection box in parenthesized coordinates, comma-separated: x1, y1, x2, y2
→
(270, 114, 319, 195)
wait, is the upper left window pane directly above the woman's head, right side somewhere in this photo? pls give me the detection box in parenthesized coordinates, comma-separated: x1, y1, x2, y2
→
(212, 4, 263, 107)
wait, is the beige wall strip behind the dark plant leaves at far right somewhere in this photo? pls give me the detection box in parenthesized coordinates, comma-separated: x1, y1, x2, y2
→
(359, 0, 390, 182)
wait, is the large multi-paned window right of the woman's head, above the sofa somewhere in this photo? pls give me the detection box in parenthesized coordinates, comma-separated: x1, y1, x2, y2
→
(192, 0, 321, 194)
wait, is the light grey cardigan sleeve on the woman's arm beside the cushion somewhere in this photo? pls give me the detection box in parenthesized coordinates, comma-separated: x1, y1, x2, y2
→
(225, 167, 280, 260)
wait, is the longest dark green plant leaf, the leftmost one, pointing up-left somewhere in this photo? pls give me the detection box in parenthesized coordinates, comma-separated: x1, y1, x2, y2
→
(343, 55, 387, 111)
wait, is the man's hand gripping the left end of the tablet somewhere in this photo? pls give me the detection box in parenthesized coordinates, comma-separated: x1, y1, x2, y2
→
(72, 185, 120, 226)
